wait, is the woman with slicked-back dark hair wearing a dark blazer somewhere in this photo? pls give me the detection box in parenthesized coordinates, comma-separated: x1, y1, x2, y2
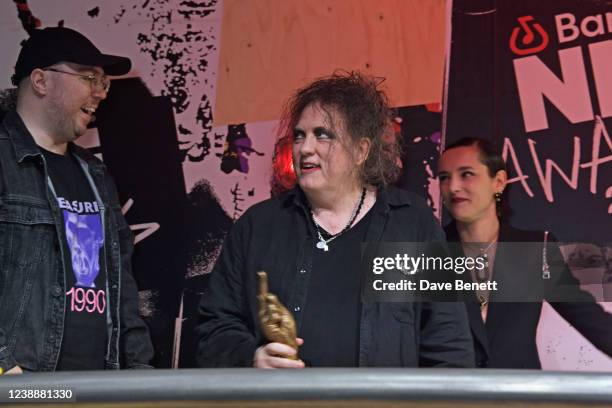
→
(438, 138, 612, 368)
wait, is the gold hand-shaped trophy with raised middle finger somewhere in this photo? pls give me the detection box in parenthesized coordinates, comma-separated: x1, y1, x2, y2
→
(257, 272, 299, 360)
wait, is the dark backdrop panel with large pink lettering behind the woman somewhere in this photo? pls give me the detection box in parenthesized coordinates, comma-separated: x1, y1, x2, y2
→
(444, 0, 612, 369)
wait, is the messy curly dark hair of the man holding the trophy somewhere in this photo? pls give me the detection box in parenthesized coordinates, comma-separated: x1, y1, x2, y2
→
(280, 71, 401, 187)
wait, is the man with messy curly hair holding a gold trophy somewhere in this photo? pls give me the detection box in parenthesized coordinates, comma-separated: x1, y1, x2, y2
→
(197, 73, 474, 368)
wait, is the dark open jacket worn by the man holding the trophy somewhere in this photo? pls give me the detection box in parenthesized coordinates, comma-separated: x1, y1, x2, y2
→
(196, 187, 474, 367)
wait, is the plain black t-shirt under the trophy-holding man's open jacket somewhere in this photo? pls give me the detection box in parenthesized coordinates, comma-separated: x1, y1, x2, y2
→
(298, 207, 371, 367)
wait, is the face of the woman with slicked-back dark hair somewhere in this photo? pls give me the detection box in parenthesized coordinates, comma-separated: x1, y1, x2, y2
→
(438, 146, 506, 223)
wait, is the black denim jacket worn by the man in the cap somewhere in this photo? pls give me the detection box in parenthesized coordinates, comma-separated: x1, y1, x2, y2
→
(0, 111, 153, 371)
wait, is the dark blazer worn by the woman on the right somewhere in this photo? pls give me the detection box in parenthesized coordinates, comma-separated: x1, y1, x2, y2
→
(445, 222, 612, 368)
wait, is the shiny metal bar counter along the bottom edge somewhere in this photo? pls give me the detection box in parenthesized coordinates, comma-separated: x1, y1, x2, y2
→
(0, 369, 612, 407)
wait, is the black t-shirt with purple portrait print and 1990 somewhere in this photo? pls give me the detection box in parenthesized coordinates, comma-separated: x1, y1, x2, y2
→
(41, 149, 107, 370)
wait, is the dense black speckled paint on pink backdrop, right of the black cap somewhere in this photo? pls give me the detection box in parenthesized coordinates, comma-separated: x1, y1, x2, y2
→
(115, 0, 218, 162)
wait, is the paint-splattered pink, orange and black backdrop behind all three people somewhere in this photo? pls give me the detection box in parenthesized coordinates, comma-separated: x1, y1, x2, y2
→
(0, 0, 612, 370)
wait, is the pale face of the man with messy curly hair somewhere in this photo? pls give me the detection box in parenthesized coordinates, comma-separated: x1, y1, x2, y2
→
(293, 104, 359, 196)
